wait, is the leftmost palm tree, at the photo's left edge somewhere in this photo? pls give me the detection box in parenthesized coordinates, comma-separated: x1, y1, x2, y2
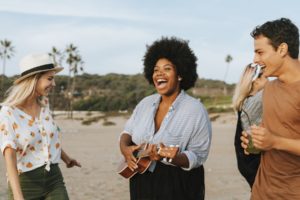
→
(0, 39, 14, 91)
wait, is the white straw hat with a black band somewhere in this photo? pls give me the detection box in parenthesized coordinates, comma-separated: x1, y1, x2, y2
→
(14, 53, 63, 84)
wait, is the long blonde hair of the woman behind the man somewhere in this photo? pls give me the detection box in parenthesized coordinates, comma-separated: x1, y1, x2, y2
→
(232, 64, 256, 111)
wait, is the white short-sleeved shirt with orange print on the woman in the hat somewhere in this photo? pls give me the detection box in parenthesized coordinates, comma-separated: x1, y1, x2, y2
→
(0, 100, 61, 173)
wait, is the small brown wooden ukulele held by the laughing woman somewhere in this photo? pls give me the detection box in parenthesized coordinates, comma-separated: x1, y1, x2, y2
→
(117, 144, 179, 179)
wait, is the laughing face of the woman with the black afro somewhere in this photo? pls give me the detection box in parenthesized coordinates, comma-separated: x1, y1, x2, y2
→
(152, 58, 180, 96)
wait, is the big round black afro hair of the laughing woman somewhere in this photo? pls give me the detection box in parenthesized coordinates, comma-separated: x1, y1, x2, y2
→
(144, 37, 198, 90)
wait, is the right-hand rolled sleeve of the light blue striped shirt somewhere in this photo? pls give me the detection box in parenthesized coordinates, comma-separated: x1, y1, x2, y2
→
(182, 108, 212, 171)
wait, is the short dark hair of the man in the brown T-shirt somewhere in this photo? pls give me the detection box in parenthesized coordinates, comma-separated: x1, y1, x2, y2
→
(251, 18, 299, 58)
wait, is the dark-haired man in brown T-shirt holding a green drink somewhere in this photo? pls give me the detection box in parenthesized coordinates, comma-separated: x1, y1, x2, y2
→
(241, 18, 300, 200)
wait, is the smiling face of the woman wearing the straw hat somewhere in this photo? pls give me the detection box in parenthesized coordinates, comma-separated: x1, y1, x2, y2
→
(36, 71, 55, 96)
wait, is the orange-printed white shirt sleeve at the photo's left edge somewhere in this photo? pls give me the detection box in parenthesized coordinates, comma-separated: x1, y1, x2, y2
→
(0, 116, 17, 155)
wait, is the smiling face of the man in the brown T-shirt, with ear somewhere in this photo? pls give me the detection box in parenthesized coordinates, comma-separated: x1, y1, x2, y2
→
(254, 35, 287, 77)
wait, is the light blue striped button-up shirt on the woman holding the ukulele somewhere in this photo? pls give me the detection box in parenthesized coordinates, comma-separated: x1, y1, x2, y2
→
(122, 90, 211, 171)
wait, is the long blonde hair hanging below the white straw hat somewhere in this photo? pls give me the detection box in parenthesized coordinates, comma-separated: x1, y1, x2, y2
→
(1, 73, 43, 106)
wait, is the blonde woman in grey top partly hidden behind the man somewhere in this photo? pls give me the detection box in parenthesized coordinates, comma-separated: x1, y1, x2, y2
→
(233, 64, 268, 187)
